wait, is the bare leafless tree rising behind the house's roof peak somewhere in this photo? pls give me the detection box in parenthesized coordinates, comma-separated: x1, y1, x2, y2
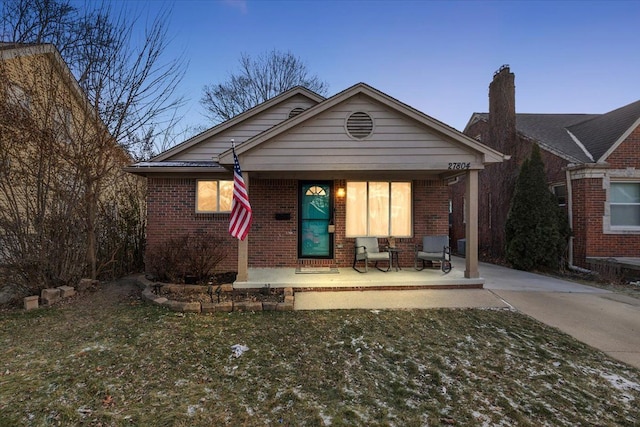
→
(200, 50, 327, 123)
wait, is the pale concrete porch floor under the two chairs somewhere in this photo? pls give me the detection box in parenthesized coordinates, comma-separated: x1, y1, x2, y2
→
(233, 256, 484, 292)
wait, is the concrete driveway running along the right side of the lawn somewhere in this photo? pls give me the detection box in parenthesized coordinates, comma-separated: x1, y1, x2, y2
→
(480, 263, 640, 368)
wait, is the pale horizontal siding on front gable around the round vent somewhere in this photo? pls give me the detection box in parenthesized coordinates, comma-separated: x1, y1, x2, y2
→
(243, 95, 482, 171)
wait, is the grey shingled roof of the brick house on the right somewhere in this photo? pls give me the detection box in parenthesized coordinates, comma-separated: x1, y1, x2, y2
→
(465, 100, 640, 163)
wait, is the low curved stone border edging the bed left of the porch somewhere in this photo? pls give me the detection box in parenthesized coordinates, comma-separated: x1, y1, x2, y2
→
(137, 275, 295, 313)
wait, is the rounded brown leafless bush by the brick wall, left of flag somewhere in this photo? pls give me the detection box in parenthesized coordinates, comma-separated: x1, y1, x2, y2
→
(146, 232, 225, 283)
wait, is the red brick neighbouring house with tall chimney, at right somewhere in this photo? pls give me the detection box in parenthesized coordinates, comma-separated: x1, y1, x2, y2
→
(451, 67, 640, 268)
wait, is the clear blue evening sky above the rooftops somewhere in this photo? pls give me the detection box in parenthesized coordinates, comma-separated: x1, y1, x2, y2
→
(132, 0, 640, 135)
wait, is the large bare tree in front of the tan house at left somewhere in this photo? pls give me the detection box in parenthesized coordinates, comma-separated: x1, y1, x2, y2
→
(0, 0, 185, 290)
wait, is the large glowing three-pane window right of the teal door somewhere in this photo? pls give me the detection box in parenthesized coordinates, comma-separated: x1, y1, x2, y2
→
(346, 182, 412, 237)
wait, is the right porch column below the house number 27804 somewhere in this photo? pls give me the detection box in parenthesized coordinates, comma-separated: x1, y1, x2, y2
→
(464, 170, 480, 279)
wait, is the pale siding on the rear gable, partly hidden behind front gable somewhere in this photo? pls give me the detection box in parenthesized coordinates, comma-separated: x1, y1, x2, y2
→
(166, 95, 316, 161)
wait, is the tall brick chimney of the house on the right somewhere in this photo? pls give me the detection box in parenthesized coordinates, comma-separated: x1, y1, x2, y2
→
(489, 65, 516, 153)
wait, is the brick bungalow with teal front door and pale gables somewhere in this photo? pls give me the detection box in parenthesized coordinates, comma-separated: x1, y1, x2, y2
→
(127, 83, 503, 282)
